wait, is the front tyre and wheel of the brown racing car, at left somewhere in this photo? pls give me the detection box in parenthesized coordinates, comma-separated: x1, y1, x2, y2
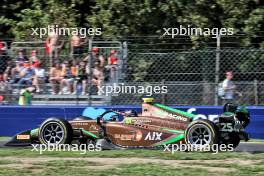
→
(38, 118, 73, 145)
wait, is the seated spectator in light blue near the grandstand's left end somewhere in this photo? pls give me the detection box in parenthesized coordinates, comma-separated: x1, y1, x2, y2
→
(18, 63, 35, 87)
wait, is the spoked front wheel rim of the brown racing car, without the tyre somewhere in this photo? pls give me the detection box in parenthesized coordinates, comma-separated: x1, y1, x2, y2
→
(42, 123, 64, 144)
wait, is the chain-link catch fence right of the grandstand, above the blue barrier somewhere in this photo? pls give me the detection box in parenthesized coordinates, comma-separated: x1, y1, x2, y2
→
(119, 49, 264, 105)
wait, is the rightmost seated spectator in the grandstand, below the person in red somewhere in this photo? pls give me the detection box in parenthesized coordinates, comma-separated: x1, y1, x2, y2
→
(92, 61, 104, 94)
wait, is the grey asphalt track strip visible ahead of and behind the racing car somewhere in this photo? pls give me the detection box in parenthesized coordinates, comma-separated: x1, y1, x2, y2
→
(0, 141, 264, 153)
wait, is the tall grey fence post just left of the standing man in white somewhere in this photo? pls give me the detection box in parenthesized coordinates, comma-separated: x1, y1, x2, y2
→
(214, 34, 220, 106)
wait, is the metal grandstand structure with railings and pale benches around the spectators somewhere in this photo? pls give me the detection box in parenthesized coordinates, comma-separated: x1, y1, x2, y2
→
(0, 40, 127, 105)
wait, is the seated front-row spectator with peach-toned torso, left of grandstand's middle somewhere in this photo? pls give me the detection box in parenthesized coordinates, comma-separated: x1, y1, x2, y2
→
(49, 62, 62, 95)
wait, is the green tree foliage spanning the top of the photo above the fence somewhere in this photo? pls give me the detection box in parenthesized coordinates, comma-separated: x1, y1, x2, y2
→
(0, 0, 264, 46)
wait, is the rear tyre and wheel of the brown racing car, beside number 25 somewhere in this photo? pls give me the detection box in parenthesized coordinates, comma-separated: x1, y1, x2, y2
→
(185, 120, 219, 148)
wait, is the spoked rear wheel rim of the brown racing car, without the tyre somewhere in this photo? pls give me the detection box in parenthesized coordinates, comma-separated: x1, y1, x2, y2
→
(188, 124, 212, 146)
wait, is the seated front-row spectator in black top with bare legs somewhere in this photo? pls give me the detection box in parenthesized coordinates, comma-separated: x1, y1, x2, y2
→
(74, 62, 88, 95)
